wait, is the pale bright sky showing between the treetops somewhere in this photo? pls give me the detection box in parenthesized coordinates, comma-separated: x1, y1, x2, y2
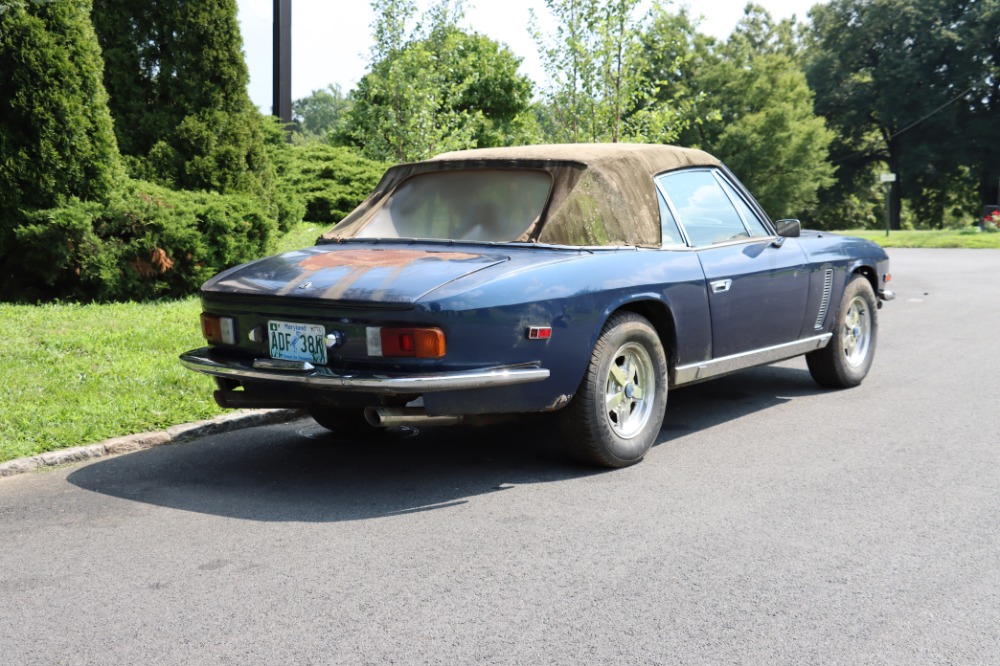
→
(237, 0, 819, 112)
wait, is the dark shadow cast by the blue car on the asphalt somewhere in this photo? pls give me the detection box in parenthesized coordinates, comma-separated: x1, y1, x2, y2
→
(68, 360, 818, 522)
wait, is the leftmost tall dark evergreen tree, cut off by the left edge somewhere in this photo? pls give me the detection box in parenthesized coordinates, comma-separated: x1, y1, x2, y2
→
(0, 0, 123, 215)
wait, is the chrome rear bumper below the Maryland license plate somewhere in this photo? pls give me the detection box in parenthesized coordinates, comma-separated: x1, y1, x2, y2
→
(180, 347, 549, 395)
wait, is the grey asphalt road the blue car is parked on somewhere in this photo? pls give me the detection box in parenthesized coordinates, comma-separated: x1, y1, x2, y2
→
(0, 250, 1000, 666)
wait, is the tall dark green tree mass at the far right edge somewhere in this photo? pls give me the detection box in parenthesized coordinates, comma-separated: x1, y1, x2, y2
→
(808, 0, 1000, 229)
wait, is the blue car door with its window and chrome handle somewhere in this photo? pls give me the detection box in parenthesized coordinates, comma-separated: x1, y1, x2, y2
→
(657, 169, 809, 359)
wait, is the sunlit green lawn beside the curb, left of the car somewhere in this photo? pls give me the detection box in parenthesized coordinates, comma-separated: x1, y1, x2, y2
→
(0, 223, 325, 462)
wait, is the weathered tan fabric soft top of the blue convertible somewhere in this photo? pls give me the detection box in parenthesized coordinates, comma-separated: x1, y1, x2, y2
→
(323, 143, 719, 247)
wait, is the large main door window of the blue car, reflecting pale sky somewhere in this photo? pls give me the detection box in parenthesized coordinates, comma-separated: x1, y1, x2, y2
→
(659, 171, 748, 247)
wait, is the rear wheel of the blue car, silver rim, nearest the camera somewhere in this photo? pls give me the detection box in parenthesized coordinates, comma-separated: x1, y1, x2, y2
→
(560, 312, 667, 467)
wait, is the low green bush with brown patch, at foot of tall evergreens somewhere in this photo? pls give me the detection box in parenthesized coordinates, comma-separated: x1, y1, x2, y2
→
(0, 176, 277, 302)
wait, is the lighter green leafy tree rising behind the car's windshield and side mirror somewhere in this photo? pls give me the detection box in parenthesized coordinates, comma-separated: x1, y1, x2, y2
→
(643, 4, 833, 219)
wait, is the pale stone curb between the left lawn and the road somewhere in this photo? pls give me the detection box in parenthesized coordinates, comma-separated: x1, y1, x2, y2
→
(0, 409, 306, 479)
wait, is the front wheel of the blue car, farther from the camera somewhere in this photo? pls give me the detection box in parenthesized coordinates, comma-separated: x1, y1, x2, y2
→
(806, 275, 878, 388)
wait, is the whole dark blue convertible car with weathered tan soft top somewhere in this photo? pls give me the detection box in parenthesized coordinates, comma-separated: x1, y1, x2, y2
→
(181, 144, 892, 467)
